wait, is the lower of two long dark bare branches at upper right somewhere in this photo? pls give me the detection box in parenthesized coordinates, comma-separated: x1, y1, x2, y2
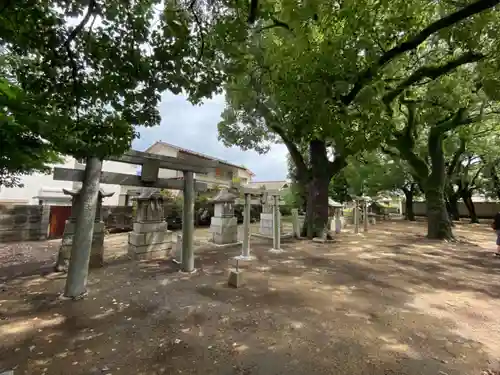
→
(383, 52, 484, 105)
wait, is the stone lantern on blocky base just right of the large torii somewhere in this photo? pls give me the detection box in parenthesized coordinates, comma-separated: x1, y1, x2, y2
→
(210, 189, 238, 245)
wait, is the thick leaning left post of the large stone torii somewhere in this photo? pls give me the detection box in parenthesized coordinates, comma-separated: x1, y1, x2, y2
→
(64, 157, 102, 298)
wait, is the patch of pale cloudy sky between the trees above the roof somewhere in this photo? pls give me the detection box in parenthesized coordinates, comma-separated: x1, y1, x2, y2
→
(133, 93, 288, 181)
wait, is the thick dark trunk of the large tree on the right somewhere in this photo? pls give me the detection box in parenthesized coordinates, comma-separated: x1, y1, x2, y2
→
(424, 131, 453, 240)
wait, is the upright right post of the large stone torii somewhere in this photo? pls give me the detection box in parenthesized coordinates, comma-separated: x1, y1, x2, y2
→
(181, 171, 194, 272)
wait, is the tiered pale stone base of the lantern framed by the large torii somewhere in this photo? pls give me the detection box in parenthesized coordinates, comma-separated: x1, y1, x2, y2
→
(128, 222, 172, 260)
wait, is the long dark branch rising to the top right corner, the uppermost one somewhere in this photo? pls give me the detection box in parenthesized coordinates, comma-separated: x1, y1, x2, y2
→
(341, 0, 500, 105)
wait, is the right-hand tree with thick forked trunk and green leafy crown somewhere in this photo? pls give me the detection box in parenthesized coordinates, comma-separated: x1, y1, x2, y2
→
(388, 68, 496, 239)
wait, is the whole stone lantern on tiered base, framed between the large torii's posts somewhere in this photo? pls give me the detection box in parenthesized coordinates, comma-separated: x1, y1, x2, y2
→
(128, 190, 172, 260)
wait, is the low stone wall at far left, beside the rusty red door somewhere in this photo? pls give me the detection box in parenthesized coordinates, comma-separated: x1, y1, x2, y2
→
(0, 205, 50, 242)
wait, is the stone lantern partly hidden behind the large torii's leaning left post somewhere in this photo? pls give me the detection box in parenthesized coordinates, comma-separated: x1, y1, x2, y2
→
(56, 189, 114, 271)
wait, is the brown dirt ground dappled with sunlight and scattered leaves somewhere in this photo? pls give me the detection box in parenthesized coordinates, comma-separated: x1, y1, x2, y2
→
(0, 222, 500, 375)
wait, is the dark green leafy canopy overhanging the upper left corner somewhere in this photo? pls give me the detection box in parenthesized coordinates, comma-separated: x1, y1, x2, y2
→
(0, 0, 235, 185)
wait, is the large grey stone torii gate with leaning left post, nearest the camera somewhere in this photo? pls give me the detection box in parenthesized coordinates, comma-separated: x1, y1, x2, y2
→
(53, 150, 218, 298)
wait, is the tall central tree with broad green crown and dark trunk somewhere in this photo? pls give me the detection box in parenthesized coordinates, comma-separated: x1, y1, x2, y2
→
(219, 0, 498, 236)
